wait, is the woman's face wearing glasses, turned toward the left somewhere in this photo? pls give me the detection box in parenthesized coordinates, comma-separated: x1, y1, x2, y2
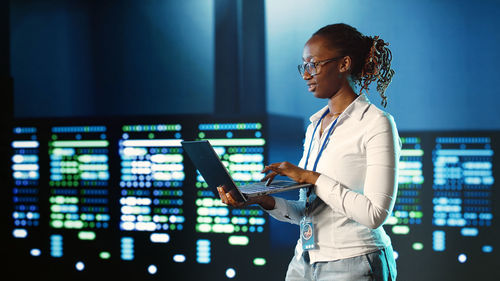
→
(302, 36, 343, 99)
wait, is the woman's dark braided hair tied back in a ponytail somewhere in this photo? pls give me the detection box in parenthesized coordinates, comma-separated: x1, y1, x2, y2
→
(313, 23, 394, 107)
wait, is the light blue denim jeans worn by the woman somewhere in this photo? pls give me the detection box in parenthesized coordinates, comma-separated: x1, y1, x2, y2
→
(286, 246, 397, 281)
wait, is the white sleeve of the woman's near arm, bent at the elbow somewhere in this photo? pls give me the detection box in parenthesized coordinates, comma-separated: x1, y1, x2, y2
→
(315, 112, 401, 229)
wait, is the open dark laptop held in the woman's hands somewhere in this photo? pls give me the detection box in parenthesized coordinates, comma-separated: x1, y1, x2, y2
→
(181, 140, 313, 202)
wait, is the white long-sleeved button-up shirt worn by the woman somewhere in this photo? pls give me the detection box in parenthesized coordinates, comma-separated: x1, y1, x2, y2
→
(268, 94, 401, 263)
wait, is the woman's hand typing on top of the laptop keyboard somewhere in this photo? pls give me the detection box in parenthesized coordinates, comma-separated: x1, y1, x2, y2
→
(262, 161, 320, 184)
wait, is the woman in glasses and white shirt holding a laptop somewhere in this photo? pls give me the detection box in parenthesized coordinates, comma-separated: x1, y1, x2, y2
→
(218, 24, 401, 281)
